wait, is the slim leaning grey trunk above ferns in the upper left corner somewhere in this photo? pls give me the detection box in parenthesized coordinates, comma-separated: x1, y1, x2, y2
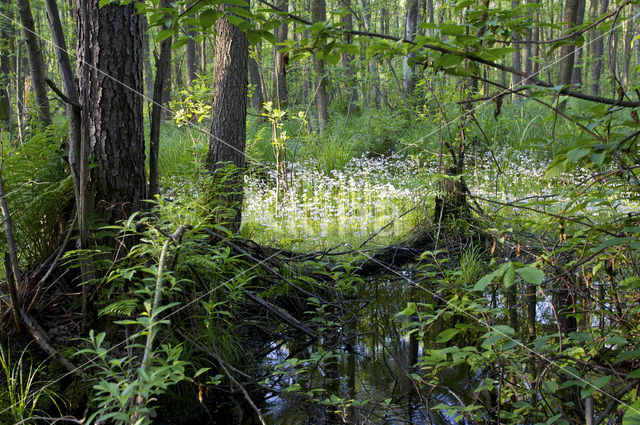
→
(18, 0, 51, 125)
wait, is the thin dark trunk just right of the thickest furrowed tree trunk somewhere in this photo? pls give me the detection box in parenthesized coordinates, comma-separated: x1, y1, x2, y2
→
(148, 0, 172, 198)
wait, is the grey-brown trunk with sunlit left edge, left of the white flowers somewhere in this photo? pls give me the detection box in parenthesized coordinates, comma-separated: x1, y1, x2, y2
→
(207, 5, 249, 230)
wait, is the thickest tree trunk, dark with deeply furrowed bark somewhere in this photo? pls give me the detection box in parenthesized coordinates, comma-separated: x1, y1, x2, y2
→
(76, 0, 146, 223)
